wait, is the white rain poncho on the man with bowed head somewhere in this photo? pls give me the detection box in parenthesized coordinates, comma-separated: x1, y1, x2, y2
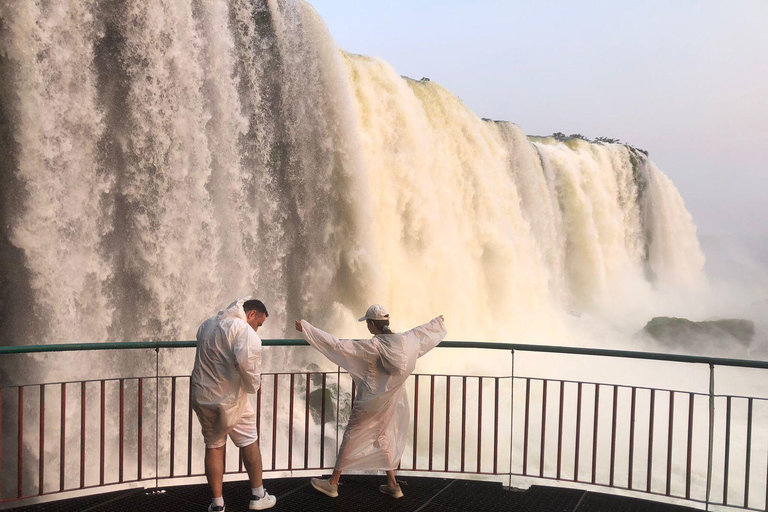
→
(190, 297, 261, 445)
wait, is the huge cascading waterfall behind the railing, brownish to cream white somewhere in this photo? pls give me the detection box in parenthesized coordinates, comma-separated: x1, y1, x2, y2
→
(0, 0, 703, 344)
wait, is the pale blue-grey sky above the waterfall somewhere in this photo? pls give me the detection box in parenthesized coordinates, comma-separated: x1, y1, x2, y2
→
(309, 0, 768, 240)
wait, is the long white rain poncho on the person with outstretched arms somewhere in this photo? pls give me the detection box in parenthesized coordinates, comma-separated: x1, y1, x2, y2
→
(301, 317, 448, 470)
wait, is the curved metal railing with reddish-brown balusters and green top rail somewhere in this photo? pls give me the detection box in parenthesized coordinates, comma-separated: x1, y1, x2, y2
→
(0, 340, 768, 510)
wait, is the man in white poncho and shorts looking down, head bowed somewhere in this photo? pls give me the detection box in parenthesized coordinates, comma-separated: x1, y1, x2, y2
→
(190, 297, 276, 512)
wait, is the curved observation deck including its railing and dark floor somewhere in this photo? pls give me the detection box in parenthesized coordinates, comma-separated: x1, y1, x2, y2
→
(0, 340, 768, 512)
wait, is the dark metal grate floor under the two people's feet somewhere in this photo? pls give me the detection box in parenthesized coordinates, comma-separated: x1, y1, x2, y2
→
(7, 475, 696, 512)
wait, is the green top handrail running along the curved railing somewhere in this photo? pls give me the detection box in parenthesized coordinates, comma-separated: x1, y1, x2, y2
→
(0, 339, 768, 370)
